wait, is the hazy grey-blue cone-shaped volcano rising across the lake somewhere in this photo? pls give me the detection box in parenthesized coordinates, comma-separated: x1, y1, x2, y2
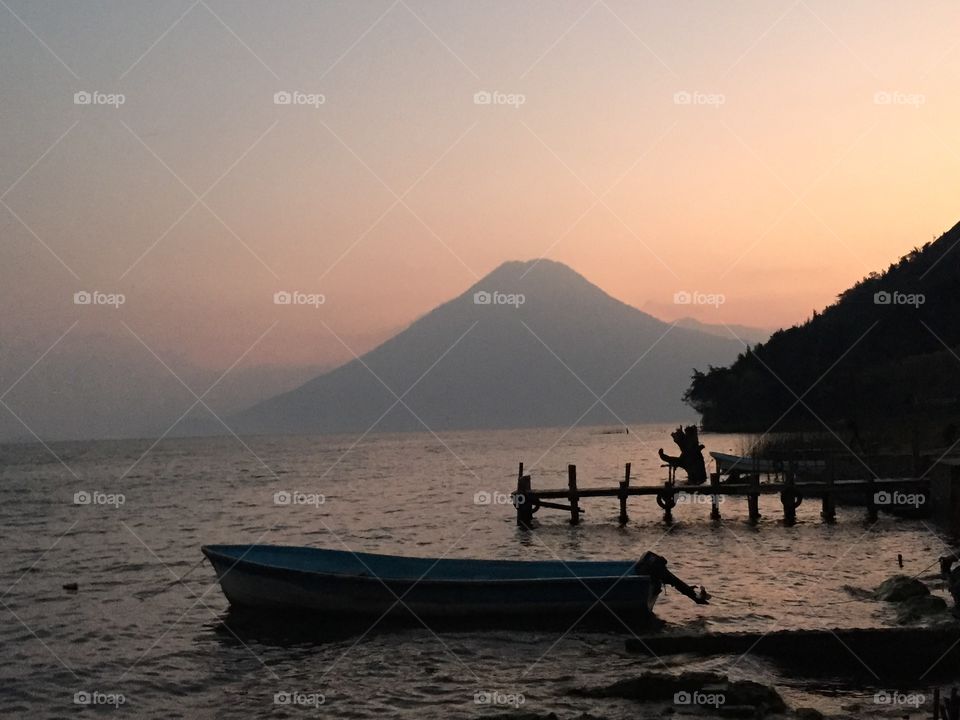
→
(231, 260, 742, 433)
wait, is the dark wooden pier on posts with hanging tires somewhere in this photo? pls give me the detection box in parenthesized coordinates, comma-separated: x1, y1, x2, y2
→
(513, 463, 930, 528)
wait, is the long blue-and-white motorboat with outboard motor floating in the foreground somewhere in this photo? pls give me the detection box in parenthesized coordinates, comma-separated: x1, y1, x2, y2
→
(202, 545, 709, 623)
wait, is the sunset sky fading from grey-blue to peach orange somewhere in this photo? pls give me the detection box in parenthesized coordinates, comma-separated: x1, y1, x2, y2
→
(0, 0, 960, 438)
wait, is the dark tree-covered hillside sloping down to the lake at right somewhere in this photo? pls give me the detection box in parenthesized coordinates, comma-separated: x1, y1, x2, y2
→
(684, 224, 960, 444)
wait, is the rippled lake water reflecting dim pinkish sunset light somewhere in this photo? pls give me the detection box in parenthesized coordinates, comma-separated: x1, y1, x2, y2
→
(0, 426, 960, 719)
